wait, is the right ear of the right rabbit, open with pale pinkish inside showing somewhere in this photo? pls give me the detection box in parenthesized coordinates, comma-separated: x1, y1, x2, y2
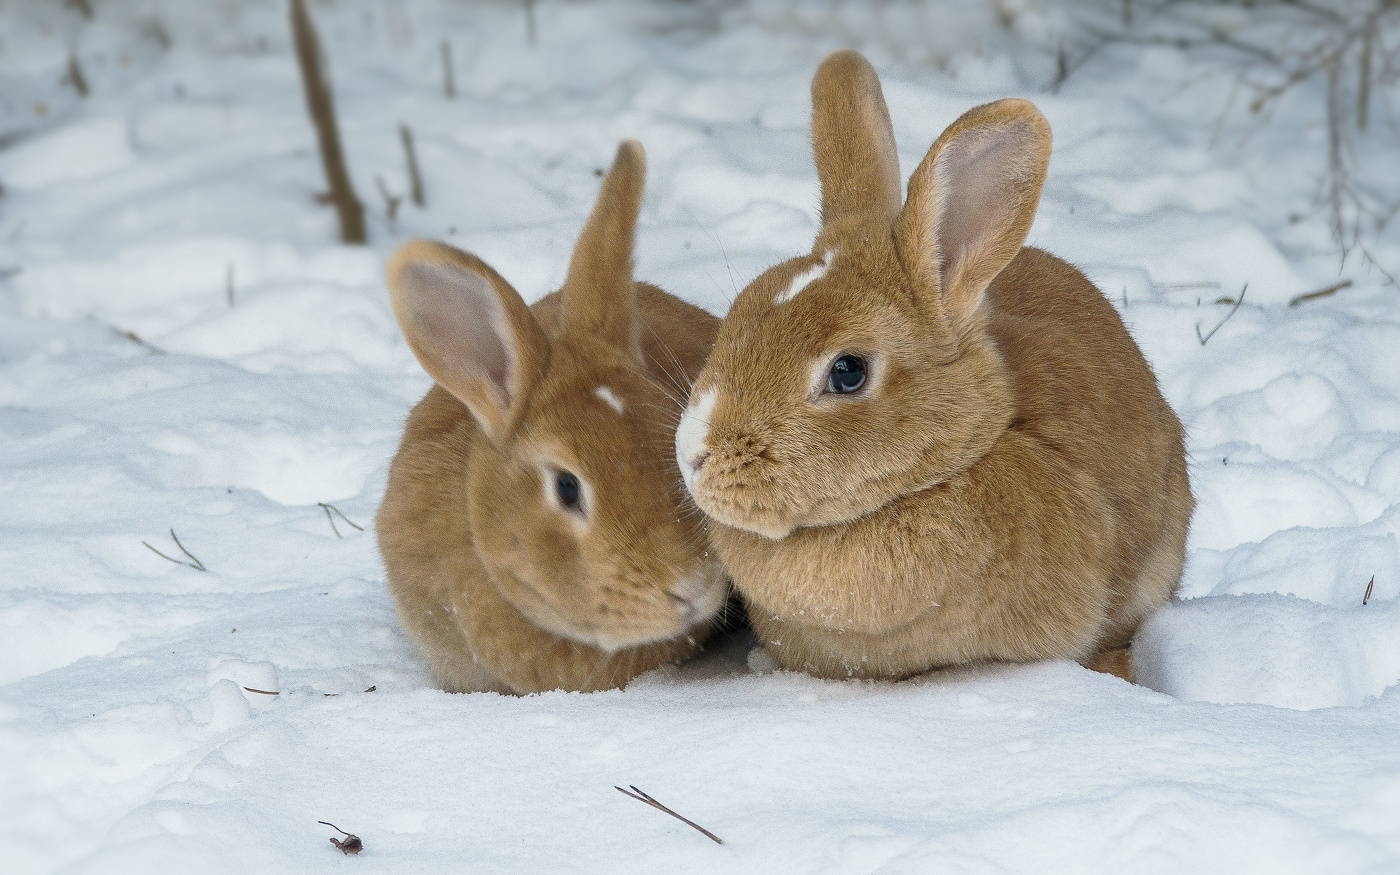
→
(895, 99, 1050, 325)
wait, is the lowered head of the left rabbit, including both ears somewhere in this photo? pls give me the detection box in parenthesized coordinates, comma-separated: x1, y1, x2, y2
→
(388, 141, 725, 651)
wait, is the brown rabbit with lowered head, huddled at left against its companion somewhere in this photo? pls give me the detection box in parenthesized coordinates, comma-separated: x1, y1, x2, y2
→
(375, 140, 728, 693)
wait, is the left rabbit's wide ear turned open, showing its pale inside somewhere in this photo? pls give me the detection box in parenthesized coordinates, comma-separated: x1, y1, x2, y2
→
(386, 239, 549, 441)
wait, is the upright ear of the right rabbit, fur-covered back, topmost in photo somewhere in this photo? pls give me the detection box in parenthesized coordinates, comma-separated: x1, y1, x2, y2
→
(812, 49, 900, 225)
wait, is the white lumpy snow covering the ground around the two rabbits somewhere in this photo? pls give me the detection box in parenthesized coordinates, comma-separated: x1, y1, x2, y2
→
(0, 0, 1400, 875)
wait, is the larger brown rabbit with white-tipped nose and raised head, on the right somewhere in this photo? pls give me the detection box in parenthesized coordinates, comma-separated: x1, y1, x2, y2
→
(676, 50, 1194, 678)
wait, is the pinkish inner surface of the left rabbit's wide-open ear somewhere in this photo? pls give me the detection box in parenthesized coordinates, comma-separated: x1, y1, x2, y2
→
(399, 263, 511, 406)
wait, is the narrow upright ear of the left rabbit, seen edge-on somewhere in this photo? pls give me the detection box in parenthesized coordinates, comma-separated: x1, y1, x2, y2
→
(560, 140, 647, 361)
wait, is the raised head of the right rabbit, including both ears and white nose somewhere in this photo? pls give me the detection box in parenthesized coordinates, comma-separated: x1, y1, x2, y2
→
(675, 52, 1050, 539)
